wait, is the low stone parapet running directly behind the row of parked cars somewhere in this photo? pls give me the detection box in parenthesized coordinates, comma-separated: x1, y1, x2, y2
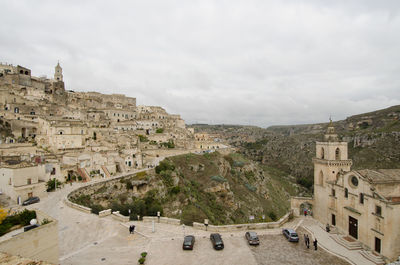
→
(193, 212, 292, 232)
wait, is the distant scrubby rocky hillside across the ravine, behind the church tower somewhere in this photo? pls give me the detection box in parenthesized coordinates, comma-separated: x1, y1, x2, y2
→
(189, 105, 400, 188)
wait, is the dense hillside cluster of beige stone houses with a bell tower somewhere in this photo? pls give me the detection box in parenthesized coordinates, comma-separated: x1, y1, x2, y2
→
(0, 63, 226, 201)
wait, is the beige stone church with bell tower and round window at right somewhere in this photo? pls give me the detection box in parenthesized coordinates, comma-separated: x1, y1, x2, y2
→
(292, 122, 400, 260)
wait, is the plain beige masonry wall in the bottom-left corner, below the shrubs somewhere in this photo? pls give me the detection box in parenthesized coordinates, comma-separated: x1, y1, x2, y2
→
(0, 210, 59, 264)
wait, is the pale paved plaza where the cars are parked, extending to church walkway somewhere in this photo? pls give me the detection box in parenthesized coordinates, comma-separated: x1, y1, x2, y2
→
(23, 183, 372, 265)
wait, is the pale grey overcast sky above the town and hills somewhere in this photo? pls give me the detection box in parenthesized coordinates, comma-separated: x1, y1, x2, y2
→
(0, 0, 400, 127)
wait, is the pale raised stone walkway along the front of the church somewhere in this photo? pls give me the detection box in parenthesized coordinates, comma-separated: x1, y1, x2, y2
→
(299, 217, 374, 265)
